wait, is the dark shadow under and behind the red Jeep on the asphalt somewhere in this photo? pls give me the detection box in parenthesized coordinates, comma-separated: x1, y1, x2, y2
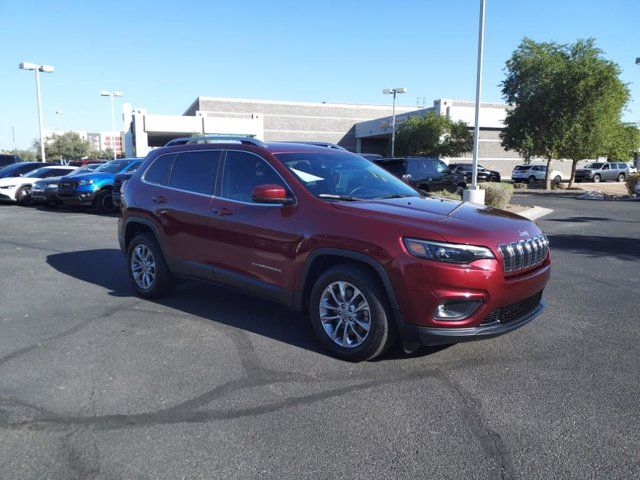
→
(47, 248, 442, 360)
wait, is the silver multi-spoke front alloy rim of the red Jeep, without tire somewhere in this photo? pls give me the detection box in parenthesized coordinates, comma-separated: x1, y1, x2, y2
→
(319, 281, 371, 348)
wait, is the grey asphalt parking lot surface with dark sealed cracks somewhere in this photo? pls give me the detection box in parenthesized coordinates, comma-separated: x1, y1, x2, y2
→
(0, 197, 640, 480)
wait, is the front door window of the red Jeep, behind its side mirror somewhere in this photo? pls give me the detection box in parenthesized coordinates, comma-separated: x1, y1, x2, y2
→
(221, 150, 286, 202)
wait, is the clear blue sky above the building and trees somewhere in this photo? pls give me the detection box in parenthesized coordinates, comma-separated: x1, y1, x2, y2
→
(0, 0, 640, 148)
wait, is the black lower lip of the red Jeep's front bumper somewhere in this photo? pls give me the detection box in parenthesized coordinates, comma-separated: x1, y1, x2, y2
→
(400, 301, 546, 346)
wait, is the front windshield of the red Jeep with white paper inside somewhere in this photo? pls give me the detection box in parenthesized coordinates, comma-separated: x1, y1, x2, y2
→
(276, 152, 420, 199)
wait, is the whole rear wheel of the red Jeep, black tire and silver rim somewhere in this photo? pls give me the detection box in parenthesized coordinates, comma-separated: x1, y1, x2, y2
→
(127, 233, 173, 298)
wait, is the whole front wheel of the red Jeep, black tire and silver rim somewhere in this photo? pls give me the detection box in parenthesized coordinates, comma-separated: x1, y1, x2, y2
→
(309, 264, 395, 362)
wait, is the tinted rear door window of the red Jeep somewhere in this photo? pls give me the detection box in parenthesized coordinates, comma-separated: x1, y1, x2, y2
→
(169, 150, 221, 195)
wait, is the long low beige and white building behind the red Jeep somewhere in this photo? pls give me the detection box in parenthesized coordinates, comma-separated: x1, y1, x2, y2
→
(123, 97, 570, 176)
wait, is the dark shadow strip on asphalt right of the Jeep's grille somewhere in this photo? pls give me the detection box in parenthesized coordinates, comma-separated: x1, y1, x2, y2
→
(547, 234, 640, 260)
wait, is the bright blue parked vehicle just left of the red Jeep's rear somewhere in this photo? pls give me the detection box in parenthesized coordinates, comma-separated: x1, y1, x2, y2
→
(58, 158, 142, 213)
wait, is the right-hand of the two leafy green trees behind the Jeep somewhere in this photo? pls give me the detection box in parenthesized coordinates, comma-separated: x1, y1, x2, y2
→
(559, 39, 637, 187)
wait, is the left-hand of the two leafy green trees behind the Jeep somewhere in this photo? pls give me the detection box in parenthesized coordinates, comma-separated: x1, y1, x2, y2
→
(500, 38, 566, 189)
